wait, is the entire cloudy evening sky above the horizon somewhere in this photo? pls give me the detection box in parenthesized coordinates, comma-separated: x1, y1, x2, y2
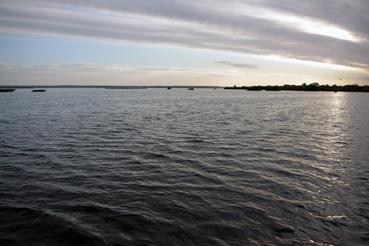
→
(0, 0, 369, 86)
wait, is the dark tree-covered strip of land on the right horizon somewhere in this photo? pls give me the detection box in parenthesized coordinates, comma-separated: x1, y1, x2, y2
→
(224, 83, 369, 92)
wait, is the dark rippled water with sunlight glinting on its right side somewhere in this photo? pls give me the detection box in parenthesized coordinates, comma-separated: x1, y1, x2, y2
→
(0, 89, 369, 246)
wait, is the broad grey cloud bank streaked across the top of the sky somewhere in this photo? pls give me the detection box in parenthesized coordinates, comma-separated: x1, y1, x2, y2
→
(0, 0, 369, 70)
